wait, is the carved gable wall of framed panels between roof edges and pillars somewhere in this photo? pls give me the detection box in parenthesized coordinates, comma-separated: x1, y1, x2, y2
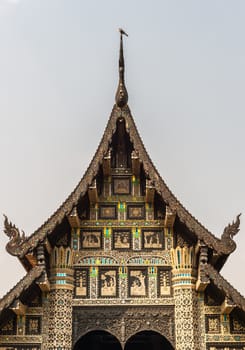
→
(63, 118, 175, 304)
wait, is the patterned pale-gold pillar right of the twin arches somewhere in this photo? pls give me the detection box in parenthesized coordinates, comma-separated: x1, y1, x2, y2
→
(172, 247, 200, 350)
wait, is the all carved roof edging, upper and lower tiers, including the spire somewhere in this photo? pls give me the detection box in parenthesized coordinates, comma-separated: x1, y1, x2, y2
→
(0, 30, 245, 326)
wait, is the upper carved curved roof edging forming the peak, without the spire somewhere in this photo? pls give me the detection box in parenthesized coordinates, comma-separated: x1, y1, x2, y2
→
(3, 105, 239, 258)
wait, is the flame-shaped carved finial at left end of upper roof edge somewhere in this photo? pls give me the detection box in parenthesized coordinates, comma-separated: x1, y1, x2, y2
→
(3, 215, 26, 255)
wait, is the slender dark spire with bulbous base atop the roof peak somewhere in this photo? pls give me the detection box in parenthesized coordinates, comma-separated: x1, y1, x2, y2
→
(116, 28, 128, 108)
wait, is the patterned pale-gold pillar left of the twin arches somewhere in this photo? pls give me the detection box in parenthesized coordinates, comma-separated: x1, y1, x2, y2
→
(43, 247, 73, 350)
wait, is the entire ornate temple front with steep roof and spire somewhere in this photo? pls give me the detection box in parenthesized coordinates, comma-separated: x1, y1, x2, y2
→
(0, 30, 245, 350)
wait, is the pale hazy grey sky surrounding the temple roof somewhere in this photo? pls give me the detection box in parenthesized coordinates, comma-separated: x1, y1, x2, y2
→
(0, 0, 245, 296)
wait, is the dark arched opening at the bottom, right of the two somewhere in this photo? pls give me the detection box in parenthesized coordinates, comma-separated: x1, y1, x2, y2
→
(124, 331, 174, 350)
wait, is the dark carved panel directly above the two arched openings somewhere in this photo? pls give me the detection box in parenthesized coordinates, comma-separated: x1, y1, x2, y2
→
(73, 306, 174, 344)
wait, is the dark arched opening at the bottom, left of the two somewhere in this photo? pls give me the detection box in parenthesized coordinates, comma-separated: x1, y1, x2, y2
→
(73, 330, 122, 350)
